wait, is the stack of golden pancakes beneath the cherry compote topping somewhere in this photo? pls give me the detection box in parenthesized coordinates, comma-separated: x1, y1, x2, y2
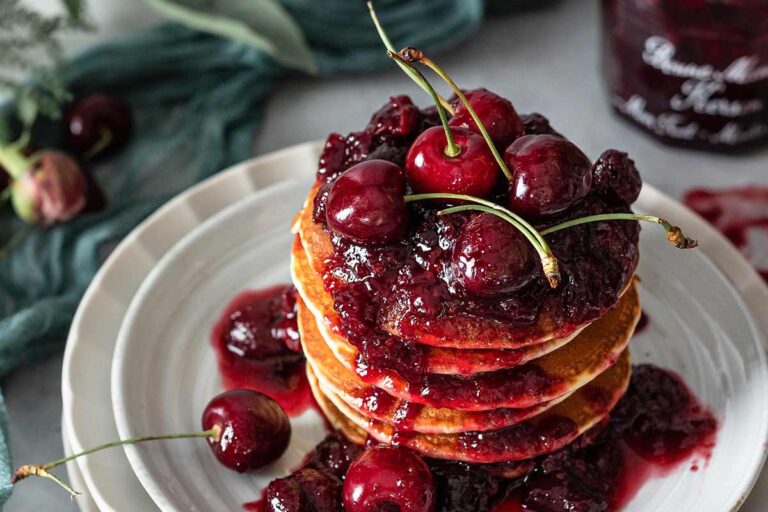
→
(291, 185, 640, 463)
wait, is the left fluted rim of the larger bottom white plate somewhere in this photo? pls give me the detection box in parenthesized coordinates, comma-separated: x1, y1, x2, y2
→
(62, 143, 321, 512)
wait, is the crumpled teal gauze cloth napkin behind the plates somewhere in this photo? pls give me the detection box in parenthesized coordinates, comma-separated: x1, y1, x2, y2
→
(0, 0, 483, 505)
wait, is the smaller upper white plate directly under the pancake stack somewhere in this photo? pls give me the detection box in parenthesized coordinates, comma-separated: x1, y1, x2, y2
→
(112, 174, 768, 512)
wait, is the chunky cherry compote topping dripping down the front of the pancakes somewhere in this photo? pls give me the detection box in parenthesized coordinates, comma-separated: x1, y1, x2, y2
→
(314, 110, 639, 408)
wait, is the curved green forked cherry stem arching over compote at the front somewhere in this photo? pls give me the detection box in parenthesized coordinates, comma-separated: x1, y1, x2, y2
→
(405, 193, 560, 288)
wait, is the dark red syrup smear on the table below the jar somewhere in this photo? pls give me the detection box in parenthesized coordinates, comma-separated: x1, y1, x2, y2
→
(683, 186, 768, 281)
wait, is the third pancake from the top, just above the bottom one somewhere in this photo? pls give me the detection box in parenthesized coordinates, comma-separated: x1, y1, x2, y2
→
(298, 286, 640, 411)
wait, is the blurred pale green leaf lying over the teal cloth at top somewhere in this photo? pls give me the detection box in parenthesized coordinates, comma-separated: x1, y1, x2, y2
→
(145, 0, 316, 73)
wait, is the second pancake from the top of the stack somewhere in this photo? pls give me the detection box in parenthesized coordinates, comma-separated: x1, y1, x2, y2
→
(291, 236, 575, 375)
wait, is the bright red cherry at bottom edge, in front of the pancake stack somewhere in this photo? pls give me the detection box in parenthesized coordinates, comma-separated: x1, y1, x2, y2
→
(343, 445, 435, 512)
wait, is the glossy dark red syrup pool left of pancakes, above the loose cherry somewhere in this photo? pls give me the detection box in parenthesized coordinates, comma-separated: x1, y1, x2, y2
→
(211, 285, 315, 416)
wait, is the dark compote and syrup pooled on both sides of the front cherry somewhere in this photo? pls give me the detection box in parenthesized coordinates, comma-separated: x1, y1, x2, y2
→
(255, 365, 717, 512)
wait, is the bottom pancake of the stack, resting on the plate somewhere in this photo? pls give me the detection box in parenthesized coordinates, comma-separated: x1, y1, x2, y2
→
(308, 350, 631, 463)
